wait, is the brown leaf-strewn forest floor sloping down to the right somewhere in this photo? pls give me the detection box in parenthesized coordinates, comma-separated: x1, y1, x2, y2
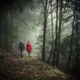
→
(0, 49, 74, 80)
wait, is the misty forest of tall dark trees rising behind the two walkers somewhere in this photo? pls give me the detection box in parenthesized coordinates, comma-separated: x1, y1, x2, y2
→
(0, 0, 80, 79)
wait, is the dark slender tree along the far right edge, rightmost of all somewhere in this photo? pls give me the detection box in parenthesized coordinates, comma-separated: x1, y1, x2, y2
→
(75, 0, 80, 72)
